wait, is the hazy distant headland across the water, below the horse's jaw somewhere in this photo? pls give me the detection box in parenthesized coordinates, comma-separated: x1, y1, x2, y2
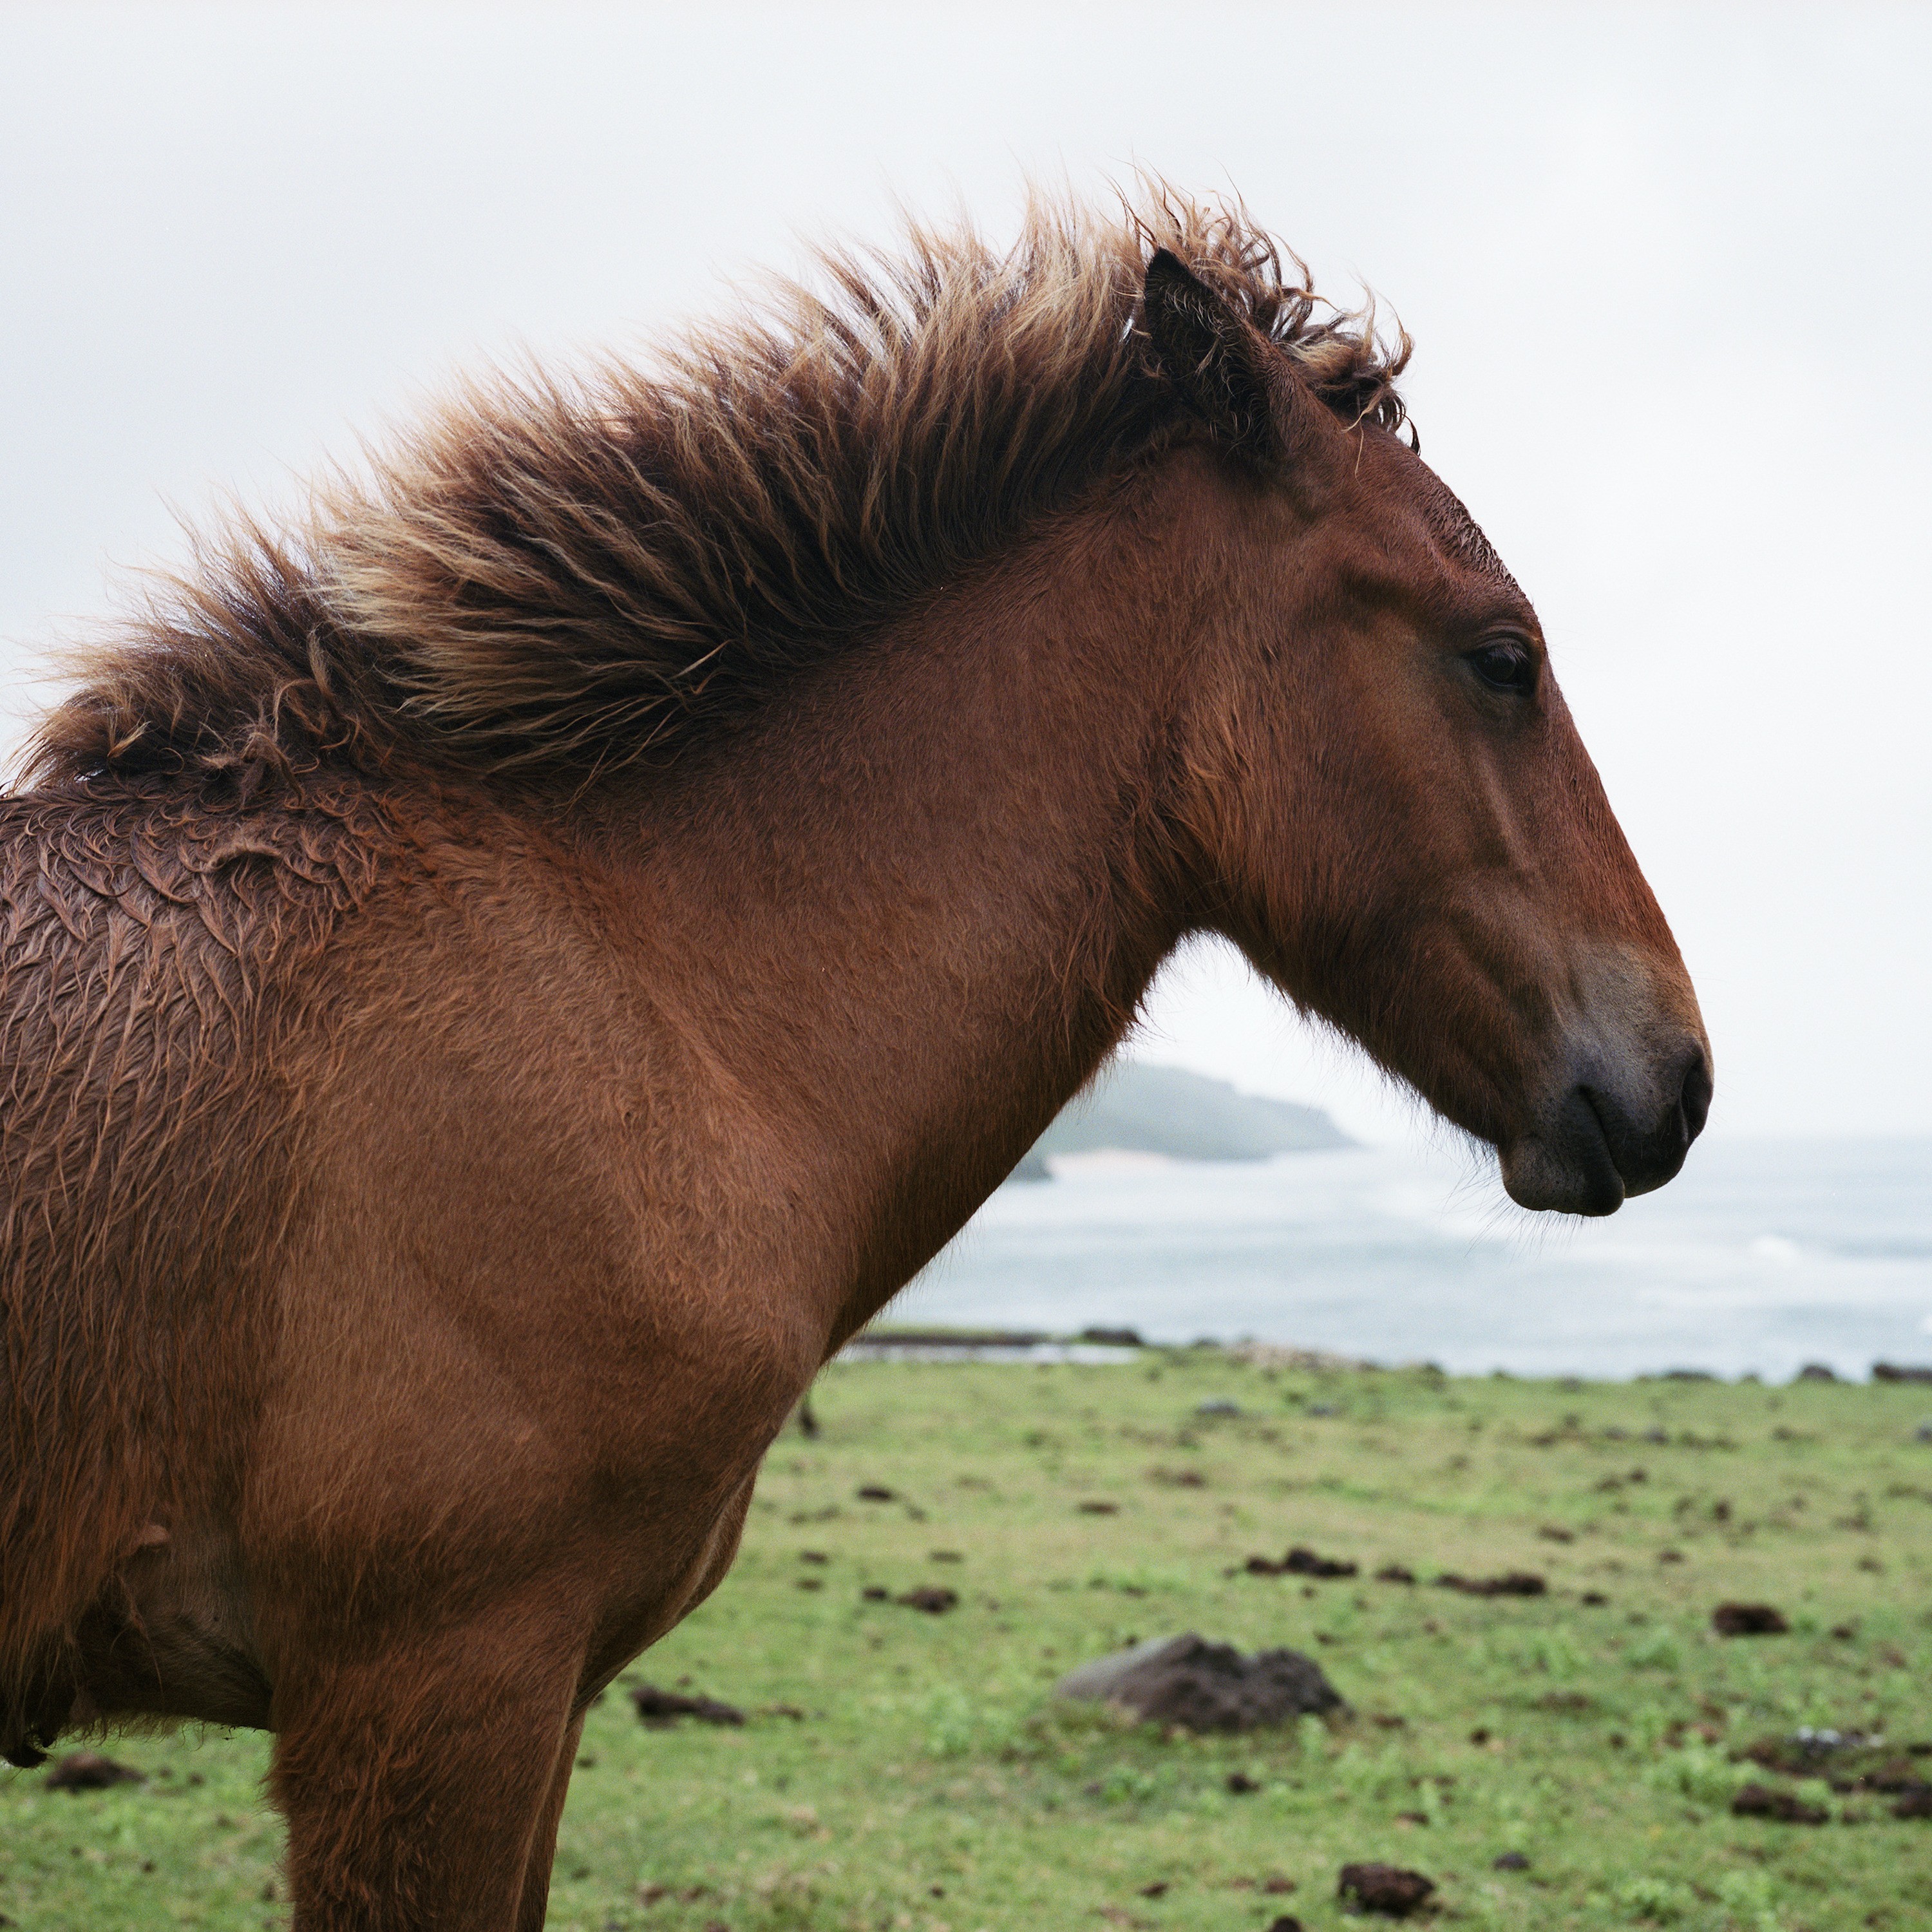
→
(1012, 1061, 1350, 1180)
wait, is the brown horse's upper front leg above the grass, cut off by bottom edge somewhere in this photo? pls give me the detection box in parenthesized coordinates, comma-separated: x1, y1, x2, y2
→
(270, 1605, 583, 1932)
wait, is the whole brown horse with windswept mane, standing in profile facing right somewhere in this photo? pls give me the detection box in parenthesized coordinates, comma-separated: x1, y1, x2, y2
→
(0, 195, 1710, 1932)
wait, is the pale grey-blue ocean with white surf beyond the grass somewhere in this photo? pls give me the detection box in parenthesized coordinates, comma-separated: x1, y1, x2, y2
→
(889, 1140, 1932, 1410)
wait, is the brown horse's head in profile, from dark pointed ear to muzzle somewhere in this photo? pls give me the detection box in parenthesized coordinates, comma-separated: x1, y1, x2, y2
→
(1144, 255, 1712, 1213)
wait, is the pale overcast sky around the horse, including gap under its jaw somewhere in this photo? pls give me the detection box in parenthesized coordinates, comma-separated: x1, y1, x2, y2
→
(0, 0, 1932, 1138)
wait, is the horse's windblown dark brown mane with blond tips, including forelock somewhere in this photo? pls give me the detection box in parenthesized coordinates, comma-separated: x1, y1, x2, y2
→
(25, 184, 1408, 794)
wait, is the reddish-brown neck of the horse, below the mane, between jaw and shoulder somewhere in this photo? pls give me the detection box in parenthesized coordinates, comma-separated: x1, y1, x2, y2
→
(607, 481, 1188, 1327)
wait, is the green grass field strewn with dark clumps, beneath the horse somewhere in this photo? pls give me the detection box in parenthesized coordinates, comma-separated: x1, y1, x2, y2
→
(0, 1349, 1932, 1932)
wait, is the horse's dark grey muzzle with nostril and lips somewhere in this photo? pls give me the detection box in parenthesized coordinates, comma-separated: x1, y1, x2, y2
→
(1499, 1036, 1712, 1215)
